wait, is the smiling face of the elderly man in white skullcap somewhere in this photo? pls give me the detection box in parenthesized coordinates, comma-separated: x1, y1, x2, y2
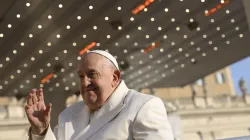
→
(78, 53, 120, 110)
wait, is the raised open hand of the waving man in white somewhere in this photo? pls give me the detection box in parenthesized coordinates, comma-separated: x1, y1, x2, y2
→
(25, 89, 52, 135)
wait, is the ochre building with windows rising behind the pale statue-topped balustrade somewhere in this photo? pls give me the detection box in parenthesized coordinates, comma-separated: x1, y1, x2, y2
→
(142, 67, 235, 100)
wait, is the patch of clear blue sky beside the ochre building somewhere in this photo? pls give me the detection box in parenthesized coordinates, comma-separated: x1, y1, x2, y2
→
(230, 57, 250, 95)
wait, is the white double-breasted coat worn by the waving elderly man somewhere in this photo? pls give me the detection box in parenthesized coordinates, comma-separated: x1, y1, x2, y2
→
(31, 81, 174, 140)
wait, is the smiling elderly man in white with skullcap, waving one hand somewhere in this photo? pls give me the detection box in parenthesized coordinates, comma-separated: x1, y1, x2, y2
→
(25, 50, 174, 140)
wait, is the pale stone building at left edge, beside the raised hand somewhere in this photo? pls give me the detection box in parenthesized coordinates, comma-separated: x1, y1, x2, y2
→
(0, 97, 30, 140)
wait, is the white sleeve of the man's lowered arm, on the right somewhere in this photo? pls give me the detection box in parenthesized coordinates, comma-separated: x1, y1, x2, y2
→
(133, 97, 174, 140)
